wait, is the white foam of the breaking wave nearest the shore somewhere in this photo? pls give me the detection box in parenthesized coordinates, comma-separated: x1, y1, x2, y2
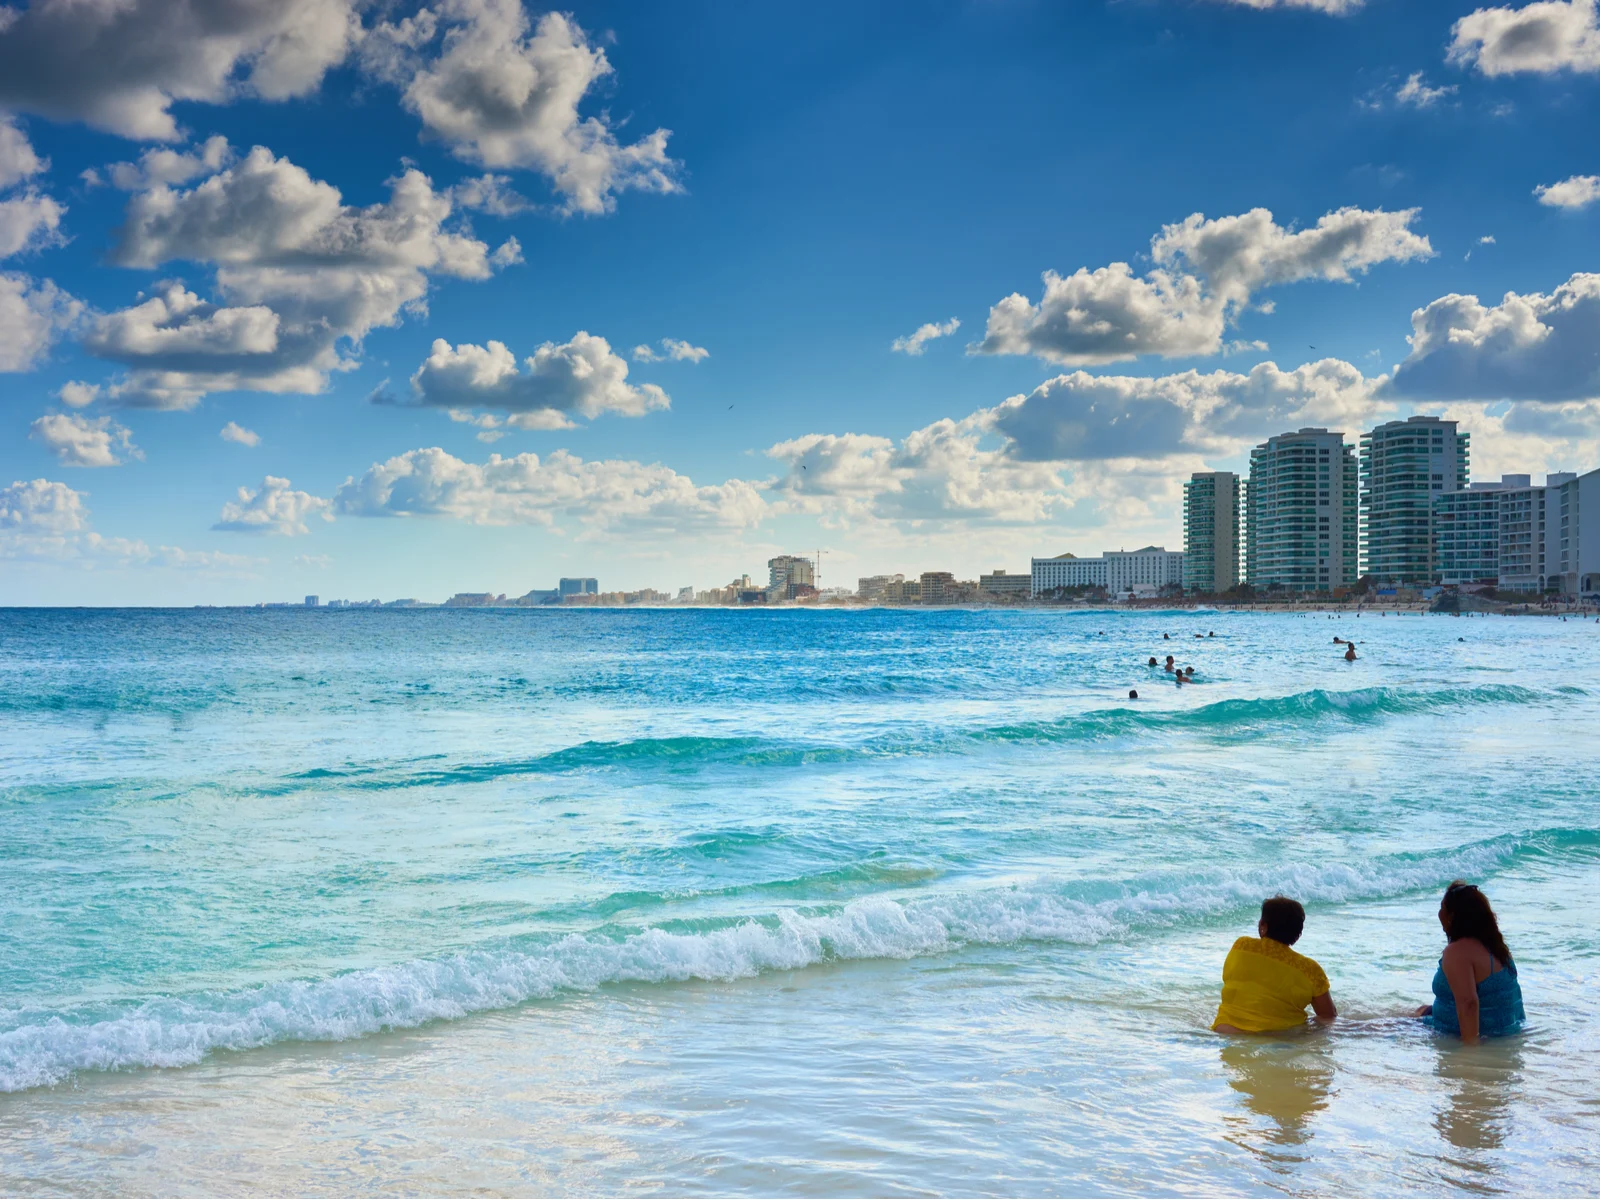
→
(0, 834, 1560, 1091)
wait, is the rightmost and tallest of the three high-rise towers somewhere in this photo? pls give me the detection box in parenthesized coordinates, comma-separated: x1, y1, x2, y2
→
(1362, 416, 1472, 586)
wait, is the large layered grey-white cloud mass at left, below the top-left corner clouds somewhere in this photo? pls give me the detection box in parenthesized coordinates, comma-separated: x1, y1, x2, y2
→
(85, 146, 517, 408)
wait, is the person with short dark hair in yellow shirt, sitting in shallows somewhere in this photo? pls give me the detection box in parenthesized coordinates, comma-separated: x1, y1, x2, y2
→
(1211, 896, 1339, 1034)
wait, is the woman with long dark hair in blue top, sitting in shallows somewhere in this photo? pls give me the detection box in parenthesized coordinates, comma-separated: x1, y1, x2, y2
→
(1416, 880, 1523, 1045)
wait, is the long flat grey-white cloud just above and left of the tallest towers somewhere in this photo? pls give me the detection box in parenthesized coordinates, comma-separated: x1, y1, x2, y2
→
(987, 358, 1379, 461)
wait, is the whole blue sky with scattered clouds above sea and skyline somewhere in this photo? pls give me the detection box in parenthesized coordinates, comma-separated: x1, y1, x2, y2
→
(0, 0, 1600, 603)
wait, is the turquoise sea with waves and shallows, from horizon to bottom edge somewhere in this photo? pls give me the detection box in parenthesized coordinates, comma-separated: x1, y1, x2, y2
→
(0, 610, 1600, 1195)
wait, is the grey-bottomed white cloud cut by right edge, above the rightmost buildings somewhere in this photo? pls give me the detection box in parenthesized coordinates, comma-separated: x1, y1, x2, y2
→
(1389, 274, 1600, 403)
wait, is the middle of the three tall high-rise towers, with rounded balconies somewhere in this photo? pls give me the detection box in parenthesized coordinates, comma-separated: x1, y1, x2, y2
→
(1245, 429, 1360, 592)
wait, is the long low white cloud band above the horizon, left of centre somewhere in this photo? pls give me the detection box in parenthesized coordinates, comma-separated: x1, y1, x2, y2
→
(334, 446, 766, 534)
